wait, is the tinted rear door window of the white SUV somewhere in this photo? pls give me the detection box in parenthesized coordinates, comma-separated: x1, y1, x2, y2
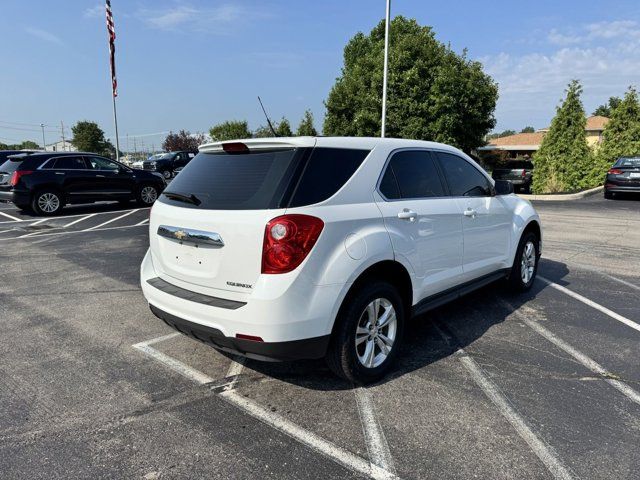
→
(380, 150, 445, 199)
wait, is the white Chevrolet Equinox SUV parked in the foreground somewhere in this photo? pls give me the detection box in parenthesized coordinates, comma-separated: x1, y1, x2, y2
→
(141, 137, 542, 382)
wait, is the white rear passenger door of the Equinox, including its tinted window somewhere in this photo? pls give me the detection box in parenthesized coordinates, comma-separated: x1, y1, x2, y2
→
(377, 150, 463, 300)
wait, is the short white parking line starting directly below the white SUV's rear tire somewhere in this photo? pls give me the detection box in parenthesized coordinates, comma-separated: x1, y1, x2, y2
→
(354, 387, 396, 475)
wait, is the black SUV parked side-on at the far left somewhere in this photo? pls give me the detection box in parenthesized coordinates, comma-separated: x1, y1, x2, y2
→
(0, 152, 166, 215)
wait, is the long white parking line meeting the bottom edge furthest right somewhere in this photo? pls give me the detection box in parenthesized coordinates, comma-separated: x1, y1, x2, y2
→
(434, 324, 576, 480)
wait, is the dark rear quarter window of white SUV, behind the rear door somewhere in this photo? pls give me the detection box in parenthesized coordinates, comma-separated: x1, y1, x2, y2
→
(289, 148, 369, 207)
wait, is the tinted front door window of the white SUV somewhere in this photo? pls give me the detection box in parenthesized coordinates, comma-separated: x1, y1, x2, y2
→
(436, 152, 491, 197)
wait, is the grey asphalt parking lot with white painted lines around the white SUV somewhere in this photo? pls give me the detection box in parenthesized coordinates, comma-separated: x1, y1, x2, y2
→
(0, 195, 640, 479)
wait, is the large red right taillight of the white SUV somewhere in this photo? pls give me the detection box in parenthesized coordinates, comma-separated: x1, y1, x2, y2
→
(262, 214, 324, 273)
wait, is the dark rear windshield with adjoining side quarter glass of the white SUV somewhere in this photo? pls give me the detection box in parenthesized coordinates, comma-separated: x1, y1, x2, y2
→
(160, 144, 369, 210)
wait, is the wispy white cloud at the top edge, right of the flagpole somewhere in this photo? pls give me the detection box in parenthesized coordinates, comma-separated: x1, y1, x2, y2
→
(136, 3, 265, 33)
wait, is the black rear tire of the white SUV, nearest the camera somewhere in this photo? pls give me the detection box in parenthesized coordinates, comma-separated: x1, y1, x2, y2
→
(325, 280, 406, 384)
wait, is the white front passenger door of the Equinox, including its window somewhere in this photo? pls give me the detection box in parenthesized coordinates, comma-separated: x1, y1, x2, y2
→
(435, 152, 513, 280)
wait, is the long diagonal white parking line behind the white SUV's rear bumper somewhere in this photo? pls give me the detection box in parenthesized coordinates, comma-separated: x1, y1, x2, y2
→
(133, 337, 398, 480)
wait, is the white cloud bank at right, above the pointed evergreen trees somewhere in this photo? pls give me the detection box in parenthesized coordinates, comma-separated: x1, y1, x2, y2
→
(480, 21, 640, 129)
